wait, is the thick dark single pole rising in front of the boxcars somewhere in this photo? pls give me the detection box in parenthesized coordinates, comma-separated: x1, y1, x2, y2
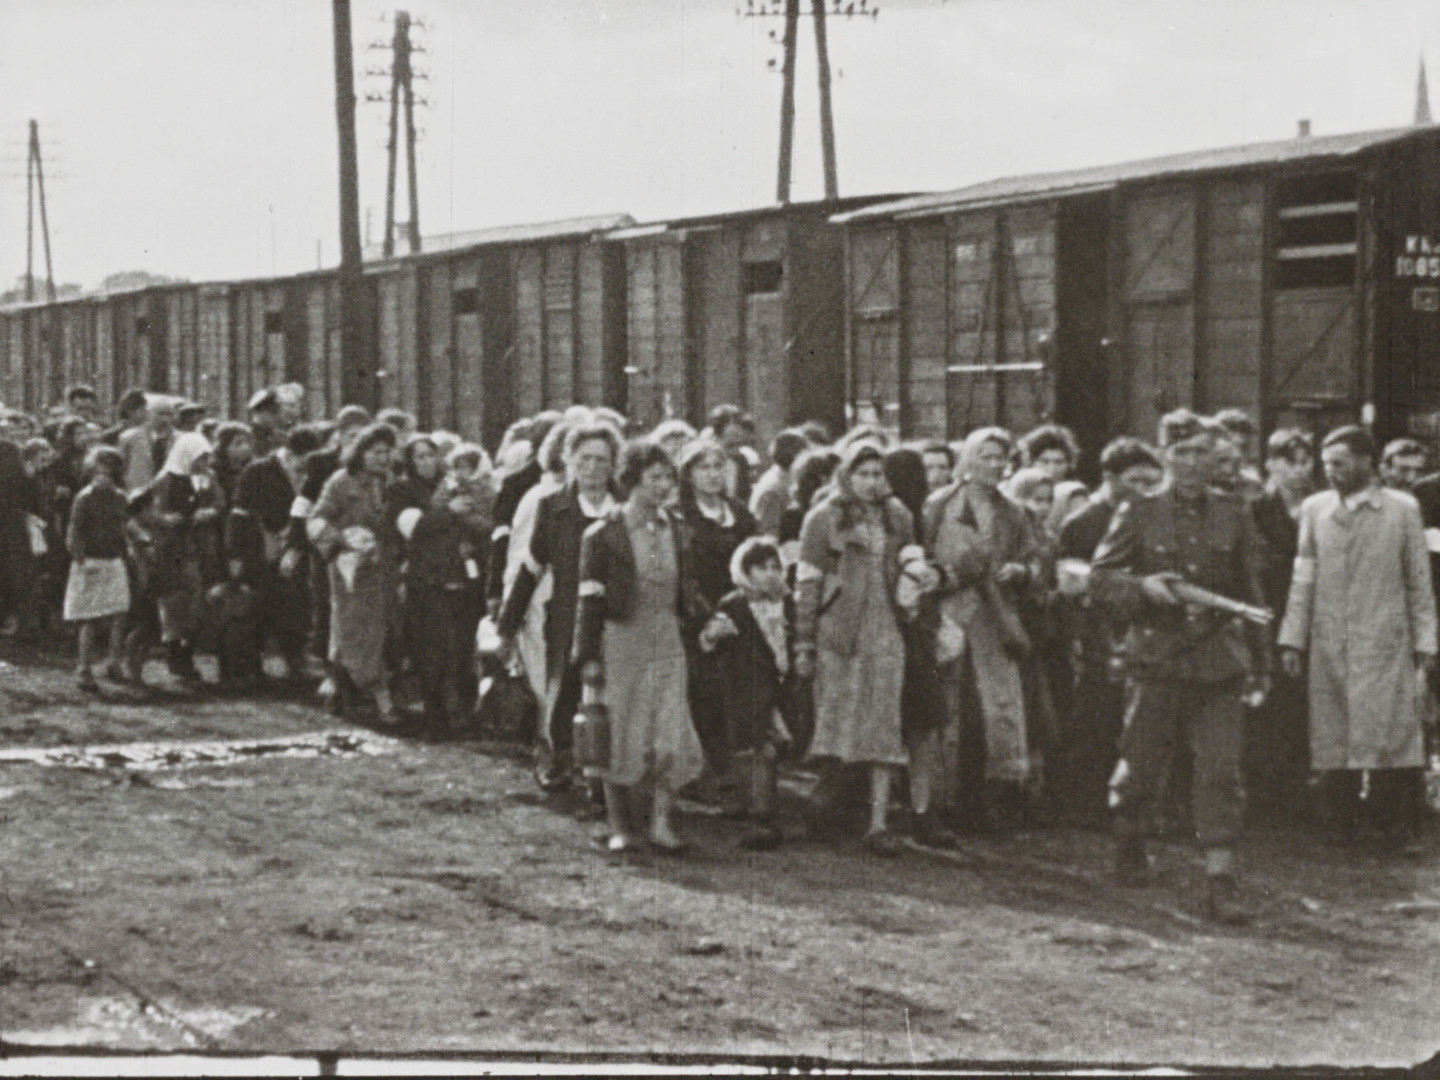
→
(331, 0, 370, 403)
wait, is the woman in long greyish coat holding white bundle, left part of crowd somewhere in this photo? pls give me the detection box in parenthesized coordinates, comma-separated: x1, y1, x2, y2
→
(305, 423, 399, 724)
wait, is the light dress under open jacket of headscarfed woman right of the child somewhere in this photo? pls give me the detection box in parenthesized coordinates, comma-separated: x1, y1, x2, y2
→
(809, 521, 909, 765)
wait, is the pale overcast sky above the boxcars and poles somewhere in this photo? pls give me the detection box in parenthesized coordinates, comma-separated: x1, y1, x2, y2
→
(0, 0, 1440, 287)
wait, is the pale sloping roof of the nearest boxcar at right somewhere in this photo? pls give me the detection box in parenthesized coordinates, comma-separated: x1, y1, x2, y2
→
(831, 127, 1434, 223)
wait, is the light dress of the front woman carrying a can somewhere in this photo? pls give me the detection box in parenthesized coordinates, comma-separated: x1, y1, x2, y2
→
(603, 516, 704, 791)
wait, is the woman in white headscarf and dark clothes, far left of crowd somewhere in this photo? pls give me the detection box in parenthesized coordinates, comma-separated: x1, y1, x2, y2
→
(150, 432, 220, 681)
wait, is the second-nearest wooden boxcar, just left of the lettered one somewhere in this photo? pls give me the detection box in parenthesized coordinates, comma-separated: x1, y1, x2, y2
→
(609, 196, 894, 438)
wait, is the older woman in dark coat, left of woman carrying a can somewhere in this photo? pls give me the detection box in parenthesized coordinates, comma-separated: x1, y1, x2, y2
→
(495, 423, 619, 791)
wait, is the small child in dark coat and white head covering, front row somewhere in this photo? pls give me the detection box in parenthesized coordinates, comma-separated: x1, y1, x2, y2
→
(700, 537, 795, 851)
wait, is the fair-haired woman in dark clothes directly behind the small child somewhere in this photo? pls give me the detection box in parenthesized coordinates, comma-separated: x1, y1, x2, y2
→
(677, 439, 755, 772)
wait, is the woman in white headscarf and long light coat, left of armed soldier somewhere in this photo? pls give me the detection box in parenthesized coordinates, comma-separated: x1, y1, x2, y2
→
(926, 428, 1043, 831)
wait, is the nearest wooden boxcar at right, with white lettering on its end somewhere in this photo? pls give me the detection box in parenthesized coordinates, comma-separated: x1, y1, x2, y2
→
(832, 127, 1440, 466)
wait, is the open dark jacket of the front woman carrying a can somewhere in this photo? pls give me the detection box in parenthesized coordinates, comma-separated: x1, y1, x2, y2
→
(573, 504, 706, 664)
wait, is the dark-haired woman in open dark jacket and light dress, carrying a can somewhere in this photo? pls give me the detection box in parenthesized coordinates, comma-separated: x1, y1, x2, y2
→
(575, 441, 703, 851)
